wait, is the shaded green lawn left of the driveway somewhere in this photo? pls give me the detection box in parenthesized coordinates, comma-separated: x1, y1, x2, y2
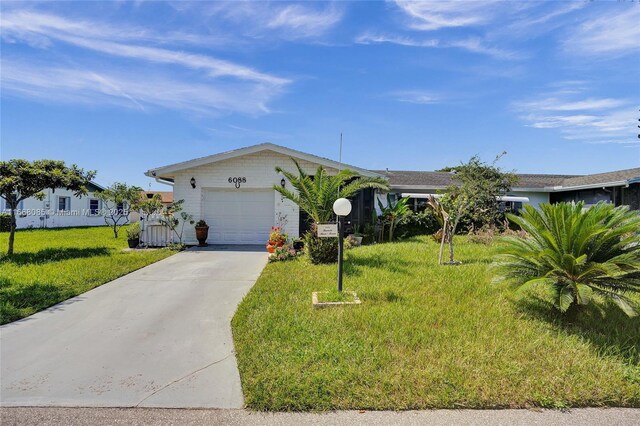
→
(0, 226, 173, 324)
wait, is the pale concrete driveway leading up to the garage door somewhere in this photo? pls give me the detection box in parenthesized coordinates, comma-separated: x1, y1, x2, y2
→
(0, 246, 267, 408)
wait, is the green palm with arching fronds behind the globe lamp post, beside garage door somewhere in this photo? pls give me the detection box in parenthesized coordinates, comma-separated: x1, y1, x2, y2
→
(273, 159, 389, 223)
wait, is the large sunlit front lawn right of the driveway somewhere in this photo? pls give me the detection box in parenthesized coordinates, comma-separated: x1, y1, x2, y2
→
(232, 238, 640, 410)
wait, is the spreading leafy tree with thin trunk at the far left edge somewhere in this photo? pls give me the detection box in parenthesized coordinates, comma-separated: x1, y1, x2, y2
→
(0, 160, 96, 256)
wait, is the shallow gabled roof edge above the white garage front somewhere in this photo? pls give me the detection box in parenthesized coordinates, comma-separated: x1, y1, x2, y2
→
(145, 143, 380, 179)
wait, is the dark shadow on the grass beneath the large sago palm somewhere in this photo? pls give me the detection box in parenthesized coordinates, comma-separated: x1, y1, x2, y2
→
(516, 296, 640, 366)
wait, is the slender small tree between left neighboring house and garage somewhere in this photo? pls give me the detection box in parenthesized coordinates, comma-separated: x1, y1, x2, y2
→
(96, 182, 142, 238)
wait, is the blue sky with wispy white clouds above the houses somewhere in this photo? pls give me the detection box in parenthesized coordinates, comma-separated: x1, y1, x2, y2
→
(0, 1, 640, 189)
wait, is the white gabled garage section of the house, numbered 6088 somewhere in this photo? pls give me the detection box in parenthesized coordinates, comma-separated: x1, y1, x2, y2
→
(145, 143, 380, 244)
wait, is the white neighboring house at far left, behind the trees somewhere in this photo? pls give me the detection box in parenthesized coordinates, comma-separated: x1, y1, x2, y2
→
(0, 182, 105, 229)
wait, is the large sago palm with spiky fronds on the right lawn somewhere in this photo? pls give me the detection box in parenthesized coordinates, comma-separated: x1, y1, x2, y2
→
(495, 202, 640, 316)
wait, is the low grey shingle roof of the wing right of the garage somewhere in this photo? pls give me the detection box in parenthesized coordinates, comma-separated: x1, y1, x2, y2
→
(376, 170, 575, 191)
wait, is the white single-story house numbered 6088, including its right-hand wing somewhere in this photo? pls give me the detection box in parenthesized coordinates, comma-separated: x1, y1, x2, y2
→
(145, 143, 640, 244)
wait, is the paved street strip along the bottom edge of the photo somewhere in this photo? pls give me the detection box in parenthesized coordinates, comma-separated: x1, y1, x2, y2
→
(0, 408, 640, 426)
